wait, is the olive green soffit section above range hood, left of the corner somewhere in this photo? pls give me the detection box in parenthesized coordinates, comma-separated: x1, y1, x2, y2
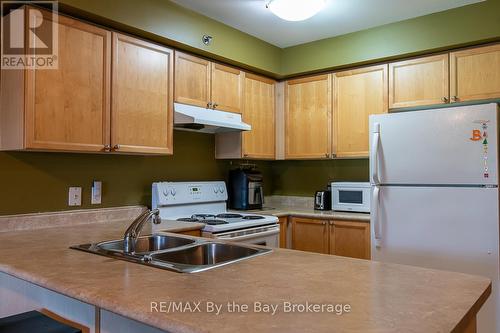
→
(55, 0, 282, 74)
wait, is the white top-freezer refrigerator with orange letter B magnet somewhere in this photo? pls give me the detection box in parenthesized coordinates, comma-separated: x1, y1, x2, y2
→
(369, 104, 500, 333)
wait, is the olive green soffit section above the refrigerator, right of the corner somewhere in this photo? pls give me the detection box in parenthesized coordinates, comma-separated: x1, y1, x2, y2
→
(281, 0, 500, 75)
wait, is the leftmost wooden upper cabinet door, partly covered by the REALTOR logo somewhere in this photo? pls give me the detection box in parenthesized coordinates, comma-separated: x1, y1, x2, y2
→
(25, 10, 111, 152)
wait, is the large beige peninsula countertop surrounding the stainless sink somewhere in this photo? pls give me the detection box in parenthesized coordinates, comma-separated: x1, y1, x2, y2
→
(0, 219, 491, 333)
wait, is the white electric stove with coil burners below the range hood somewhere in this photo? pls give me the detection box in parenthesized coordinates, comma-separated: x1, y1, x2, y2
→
(152, 181, 279, 247)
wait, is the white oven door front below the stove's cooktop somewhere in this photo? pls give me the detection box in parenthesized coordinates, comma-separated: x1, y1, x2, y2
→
(203, 224, 280, 247)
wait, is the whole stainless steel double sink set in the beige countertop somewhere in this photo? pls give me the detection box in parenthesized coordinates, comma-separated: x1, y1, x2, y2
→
(71, 233, 272, 273)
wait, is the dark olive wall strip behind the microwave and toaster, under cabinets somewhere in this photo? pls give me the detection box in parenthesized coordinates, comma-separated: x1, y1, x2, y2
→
(271, 159, 369, 196)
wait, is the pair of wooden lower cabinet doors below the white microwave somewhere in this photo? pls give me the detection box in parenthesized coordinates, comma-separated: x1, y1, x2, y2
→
(291, 217, 370, 259)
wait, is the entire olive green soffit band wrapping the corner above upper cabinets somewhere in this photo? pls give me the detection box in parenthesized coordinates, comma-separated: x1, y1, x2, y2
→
(56, 0, 500, 78)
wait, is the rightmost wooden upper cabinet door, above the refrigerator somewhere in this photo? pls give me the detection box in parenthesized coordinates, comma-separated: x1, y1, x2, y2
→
(450, 44, 500, 102)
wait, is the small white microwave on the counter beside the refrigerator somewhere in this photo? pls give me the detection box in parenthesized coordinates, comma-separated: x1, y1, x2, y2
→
(332, 182, 371, 213)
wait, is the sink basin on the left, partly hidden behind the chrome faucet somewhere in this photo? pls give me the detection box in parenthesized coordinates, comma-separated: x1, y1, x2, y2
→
(96, 235, 195, 254)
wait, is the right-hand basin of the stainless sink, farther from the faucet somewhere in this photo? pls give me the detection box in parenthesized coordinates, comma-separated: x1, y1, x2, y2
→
(151, 243, 259, 266)
